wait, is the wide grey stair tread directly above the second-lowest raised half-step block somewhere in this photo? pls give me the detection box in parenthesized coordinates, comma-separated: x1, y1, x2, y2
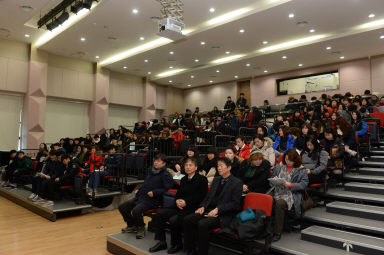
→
(326, 188, 384, 205)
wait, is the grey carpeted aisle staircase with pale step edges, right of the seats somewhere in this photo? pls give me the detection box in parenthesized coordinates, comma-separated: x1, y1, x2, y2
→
(272, 143, 384, 255)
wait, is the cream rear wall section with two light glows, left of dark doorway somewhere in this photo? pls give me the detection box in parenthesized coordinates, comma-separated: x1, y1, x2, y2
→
(184, 82, 237, 111)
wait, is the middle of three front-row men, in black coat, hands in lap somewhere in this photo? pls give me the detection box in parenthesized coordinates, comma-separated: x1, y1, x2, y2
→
(149, 158, 209, 254)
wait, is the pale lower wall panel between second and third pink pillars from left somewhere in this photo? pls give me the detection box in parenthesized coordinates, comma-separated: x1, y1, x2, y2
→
(108, 104, 140, 129)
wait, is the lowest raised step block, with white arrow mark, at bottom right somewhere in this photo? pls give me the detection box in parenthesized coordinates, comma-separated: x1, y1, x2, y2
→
(301, 226, 384, 255)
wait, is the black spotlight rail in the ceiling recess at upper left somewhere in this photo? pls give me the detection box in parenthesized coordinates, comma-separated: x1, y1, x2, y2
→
(37, 0, 98, 31)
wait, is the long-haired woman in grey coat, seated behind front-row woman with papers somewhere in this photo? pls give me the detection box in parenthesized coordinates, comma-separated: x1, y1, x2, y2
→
(301, 136, 328, 185)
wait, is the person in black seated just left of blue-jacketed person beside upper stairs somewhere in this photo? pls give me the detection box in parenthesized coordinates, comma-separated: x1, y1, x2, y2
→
(336, 117, 357, 157)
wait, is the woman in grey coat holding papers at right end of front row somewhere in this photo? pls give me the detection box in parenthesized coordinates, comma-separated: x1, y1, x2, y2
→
(272, 149, 308, 242)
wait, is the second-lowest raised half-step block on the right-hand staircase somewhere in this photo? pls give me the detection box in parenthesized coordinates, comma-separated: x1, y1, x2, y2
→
(326, 201, 384, 221)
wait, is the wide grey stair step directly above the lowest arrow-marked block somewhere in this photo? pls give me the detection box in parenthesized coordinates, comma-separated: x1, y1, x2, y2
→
(304, 207, 384, 236)
